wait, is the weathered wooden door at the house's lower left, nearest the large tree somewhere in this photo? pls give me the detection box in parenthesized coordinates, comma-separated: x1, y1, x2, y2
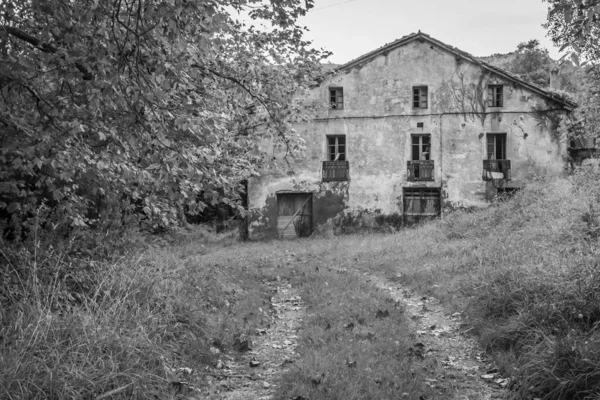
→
(277, 193, 313, 238)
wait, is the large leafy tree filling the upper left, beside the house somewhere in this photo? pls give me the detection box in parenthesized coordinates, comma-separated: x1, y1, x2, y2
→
(0, 0, 327, 236)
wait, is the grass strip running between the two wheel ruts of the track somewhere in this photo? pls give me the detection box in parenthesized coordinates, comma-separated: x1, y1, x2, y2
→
(276, 256, 431, 400)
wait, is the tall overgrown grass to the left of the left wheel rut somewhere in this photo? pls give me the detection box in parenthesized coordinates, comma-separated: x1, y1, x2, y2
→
(0, 230, 278, 399)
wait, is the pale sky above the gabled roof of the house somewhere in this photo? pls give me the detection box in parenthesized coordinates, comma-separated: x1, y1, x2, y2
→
(299, 0, 559, 64)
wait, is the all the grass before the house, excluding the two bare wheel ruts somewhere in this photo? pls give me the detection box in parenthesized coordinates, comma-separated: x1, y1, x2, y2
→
(0, 170, 600, 400)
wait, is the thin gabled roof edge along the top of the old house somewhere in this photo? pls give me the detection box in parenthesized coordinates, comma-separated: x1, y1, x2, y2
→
(334, 31, 577, 110)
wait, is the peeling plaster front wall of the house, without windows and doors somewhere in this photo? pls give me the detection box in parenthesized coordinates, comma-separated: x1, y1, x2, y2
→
(249, 40, 566, 237)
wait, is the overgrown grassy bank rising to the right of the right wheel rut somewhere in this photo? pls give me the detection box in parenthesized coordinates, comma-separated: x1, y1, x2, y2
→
(346, 168, 600, 400)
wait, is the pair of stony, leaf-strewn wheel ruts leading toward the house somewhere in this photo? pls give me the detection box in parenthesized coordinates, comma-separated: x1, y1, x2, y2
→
(187, 255, 510, 400)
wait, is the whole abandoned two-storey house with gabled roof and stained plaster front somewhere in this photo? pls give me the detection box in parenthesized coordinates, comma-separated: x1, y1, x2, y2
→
(248, 32, 576, 238)
